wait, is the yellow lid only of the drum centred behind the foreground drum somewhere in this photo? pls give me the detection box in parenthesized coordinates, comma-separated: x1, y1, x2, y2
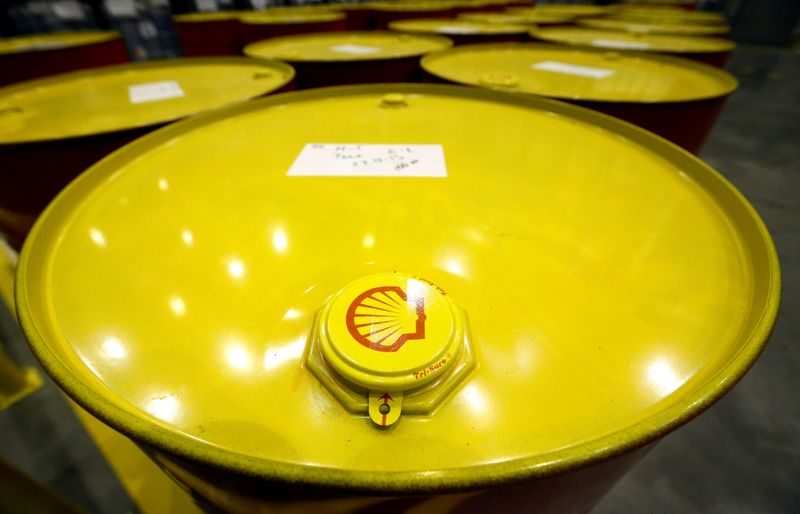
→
(244, 31, 453, 62)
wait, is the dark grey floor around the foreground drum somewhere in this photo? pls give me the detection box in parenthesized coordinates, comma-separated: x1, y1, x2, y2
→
(0, 47, 800, 514)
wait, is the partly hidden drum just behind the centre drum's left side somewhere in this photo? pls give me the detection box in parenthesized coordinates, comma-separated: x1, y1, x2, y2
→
(240, 9, 347, 43)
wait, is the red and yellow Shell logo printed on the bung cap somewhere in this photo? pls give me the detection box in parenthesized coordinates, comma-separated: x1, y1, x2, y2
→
(346, 286, 426, 352)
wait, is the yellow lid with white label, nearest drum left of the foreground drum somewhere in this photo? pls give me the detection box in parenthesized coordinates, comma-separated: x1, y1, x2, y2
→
(0, 57, 294, 144)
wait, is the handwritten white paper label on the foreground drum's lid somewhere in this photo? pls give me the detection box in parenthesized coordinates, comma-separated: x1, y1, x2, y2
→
(286, 143, 447, 177)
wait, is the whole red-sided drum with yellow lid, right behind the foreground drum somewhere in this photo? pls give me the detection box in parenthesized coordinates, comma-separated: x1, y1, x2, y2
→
(422, 43, 738, 153)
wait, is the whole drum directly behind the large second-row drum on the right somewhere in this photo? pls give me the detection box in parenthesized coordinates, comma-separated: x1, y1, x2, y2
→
(530, 27, 736, 68)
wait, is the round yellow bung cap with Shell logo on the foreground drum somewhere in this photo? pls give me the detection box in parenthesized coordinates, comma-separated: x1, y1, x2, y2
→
(320, 273, 462, 384)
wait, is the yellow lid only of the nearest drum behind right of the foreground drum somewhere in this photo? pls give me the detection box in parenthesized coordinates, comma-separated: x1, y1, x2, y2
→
(422, 43, 737, 103)
